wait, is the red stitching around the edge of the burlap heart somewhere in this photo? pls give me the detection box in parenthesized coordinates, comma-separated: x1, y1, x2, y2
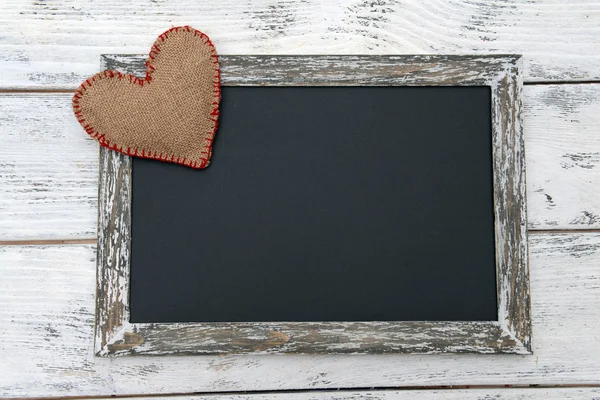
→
(73, 26, 221, 169)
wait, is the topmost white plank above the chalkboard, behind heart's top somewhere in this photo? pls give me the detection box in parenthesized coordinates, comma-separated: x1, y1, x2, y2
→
(0, 0, 600, 89)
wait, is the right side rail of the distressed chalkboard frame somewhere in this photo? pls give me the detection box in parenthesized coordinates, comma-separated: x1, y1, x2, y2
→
(490, 59, 531, 350)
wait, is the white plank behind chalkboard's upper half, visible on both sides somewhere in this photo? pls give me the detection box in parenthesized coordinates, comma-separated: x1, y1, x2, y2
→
(0, 84, 600, 240)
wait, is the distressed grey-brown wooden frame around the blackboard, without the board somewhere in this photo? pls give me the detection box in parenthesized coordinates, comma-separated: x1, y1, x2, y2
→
(95, 55, 531, 356)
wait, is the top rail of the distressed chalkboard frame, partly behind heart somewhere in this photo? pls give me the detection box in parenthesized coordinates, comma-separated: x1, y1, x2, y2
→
(106, 54, 522, 86)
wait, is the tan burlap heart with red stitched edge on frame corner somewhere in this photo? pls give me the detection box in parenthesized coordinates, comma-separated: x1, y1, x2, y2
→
(73, 26, 221, 168)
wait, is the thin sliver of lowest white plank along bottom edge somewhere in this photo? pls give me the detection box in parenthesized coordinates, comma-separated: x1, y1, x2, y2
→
(89, 388, 600, 400)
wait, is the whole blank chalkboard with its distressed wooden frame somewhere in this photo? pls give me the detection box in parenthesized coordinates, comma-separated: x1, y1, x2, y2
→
(92, 56, 531, 355)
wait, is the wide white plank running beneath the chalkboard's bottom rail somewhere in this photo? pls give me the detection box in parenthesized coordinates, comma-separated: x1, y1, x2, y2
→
(0, 233, 600, 397)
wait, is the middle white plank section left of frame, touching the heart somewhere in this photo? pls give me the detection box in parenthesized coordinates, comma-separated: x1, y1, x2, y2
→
(0, 94, 98, 240)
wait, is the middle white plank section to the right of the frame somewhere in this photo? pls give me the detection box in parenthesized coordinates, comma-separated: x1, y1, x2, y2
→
(523, 84, 600, 229)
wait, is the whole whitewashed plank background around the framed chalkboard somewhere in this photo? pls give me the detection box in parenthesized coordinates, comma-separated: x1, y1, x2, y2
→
(0, 0, 600, 400)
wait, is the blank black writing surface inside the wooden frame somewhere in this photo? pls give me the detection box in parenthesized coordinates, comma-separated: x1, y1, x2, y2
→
(130, 87, 497, 322)
